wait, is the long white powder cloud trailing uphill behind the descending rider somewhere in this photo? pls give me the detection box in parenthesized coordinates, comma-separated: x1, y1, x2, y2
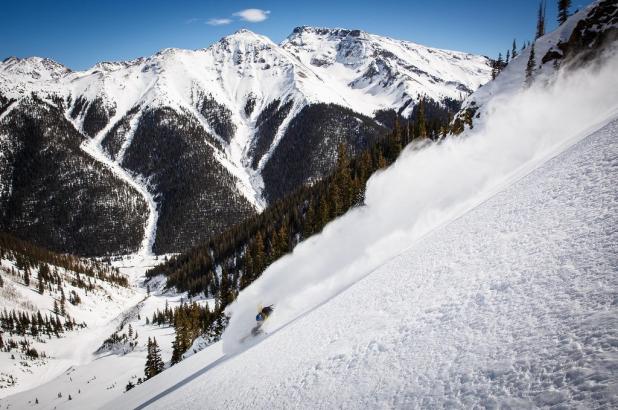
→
(223, 44, 618, 353)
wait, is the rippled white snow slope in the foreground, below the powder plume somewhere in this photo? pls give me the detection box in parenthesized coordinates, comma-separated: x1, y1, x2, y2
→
(115, 114, 618, 409)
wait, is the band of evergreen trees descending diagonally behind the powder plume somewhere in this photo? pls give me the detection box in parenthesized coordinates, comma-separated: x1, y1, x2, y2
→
(146, 97, 459, 363)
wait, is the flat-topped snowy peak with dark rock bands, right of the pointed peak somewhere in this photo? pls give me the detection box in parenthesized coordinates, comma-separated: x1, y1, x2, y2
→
(282, 27, 488, 116)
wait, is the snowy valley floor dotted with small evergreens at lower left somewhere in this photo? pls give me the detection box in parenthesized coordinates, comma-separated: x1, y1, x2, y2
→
(0, 247, 214, 408)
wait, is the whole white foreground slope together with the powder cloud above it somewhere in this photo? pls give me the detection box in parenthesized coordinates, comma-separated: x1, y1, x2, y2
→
(107, 29, 618, 409)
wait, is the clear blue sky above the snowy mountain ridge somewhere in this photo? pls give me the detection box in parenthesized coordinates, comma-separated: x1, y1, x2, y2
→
(0, 0, 590, 70)
